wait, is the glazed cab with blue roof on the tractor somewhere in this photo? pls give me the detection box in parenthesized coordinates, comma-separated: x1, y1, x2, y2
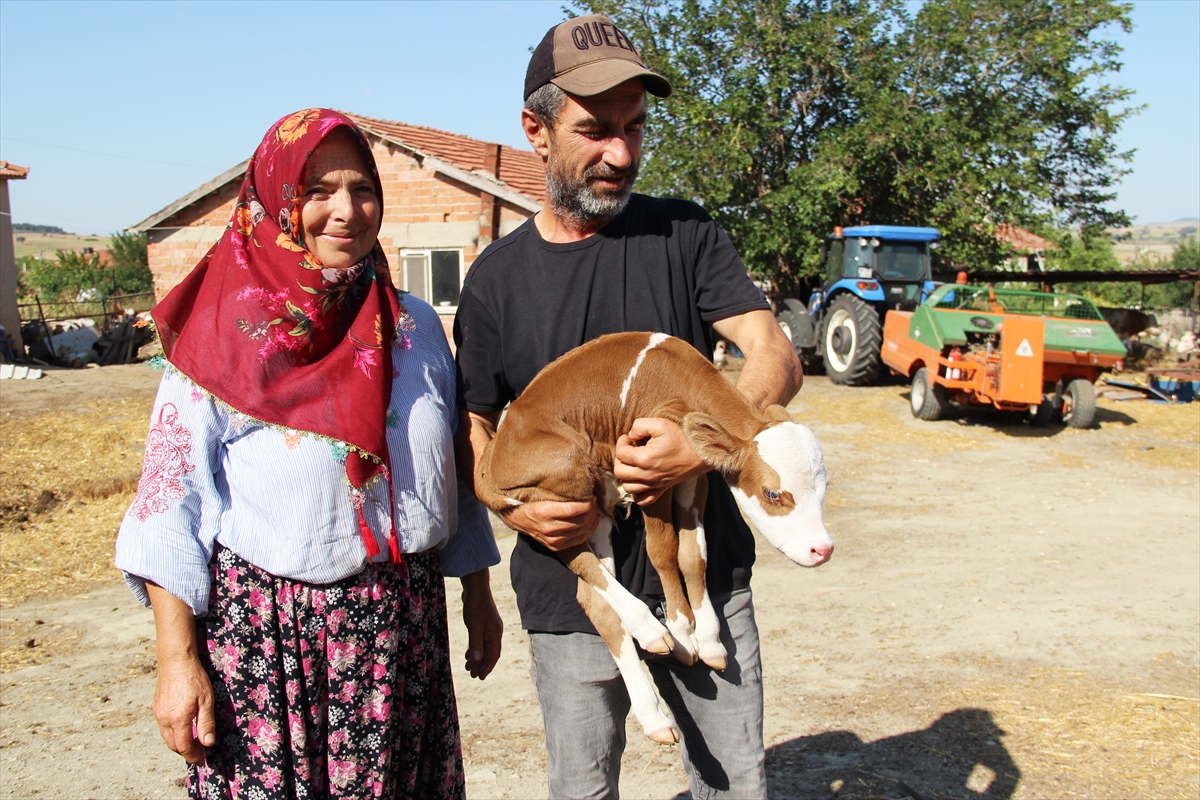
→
(821, 225, 942, 309)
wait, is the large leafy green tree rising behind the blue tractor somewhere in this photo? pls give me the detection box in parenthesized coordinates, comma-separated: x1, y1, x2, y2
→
(581, 0, 1136, 291)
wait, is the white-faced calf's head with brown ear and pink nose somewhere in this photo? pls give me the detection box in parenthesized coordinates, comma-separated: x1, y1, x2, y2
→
(683, 407, 833, 566)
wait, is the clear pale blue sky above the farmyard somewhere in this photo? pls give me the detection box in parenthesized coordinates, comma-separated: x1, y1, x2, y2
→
(0, 0, 1200, 233)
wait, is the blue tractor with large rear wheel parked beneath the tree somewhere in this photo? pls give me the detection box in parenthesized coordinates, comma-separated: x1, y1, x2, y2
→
(775, 225, 942, 386)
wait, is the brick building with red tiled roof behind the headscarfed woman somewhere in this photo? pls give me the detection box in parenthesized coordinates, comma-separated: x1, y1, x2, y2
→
(130, 113, 545, 343)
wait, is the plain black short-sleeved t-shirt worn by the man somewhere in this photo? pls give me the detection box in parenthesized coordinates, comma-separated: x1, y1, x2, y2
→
(454, 194, 769, 632)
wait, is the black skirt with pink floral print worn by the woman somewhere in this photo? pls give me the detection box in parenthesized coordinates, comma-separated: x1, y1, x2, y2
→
(187, 547, 464, 800)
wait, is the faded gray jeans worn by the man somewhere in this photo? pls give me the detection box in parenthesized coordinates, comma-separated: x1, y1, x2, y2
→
(529, 589, 767, 800)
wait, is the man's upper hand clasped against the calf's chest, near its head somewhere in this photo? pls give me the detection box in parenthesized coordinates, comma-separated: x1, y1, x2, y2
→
(612, 417, 709, 506)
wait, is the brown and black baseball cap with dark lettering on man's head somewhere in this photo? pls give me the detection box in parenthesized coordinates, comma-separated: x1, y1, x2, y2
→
(524, 14, 671, 100)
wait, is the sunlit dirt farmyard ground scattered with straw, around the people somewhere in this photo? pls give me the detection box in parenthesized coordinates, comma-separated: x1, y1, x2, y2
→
(0, 367, 1200, 800)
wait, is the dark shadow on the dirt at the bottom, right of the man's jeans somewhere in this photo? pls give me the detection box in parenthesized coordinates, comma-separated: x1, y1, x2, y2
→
(767, 709, 1021, 800)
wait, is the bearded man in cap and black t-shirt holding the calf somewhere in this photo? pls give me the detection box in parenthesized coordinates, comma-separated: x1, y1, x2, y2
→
(455, 16, 802, 798)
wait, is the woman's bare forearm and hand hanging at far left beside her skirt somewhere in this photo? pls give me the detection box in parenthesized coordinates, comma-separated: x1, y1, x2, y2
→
(146, 582, 217, 764)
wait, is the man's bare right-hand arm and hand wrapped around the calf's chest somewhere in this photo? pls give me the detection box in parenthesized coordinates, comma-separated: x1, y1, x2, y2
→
(613, 309, 804, 506)
